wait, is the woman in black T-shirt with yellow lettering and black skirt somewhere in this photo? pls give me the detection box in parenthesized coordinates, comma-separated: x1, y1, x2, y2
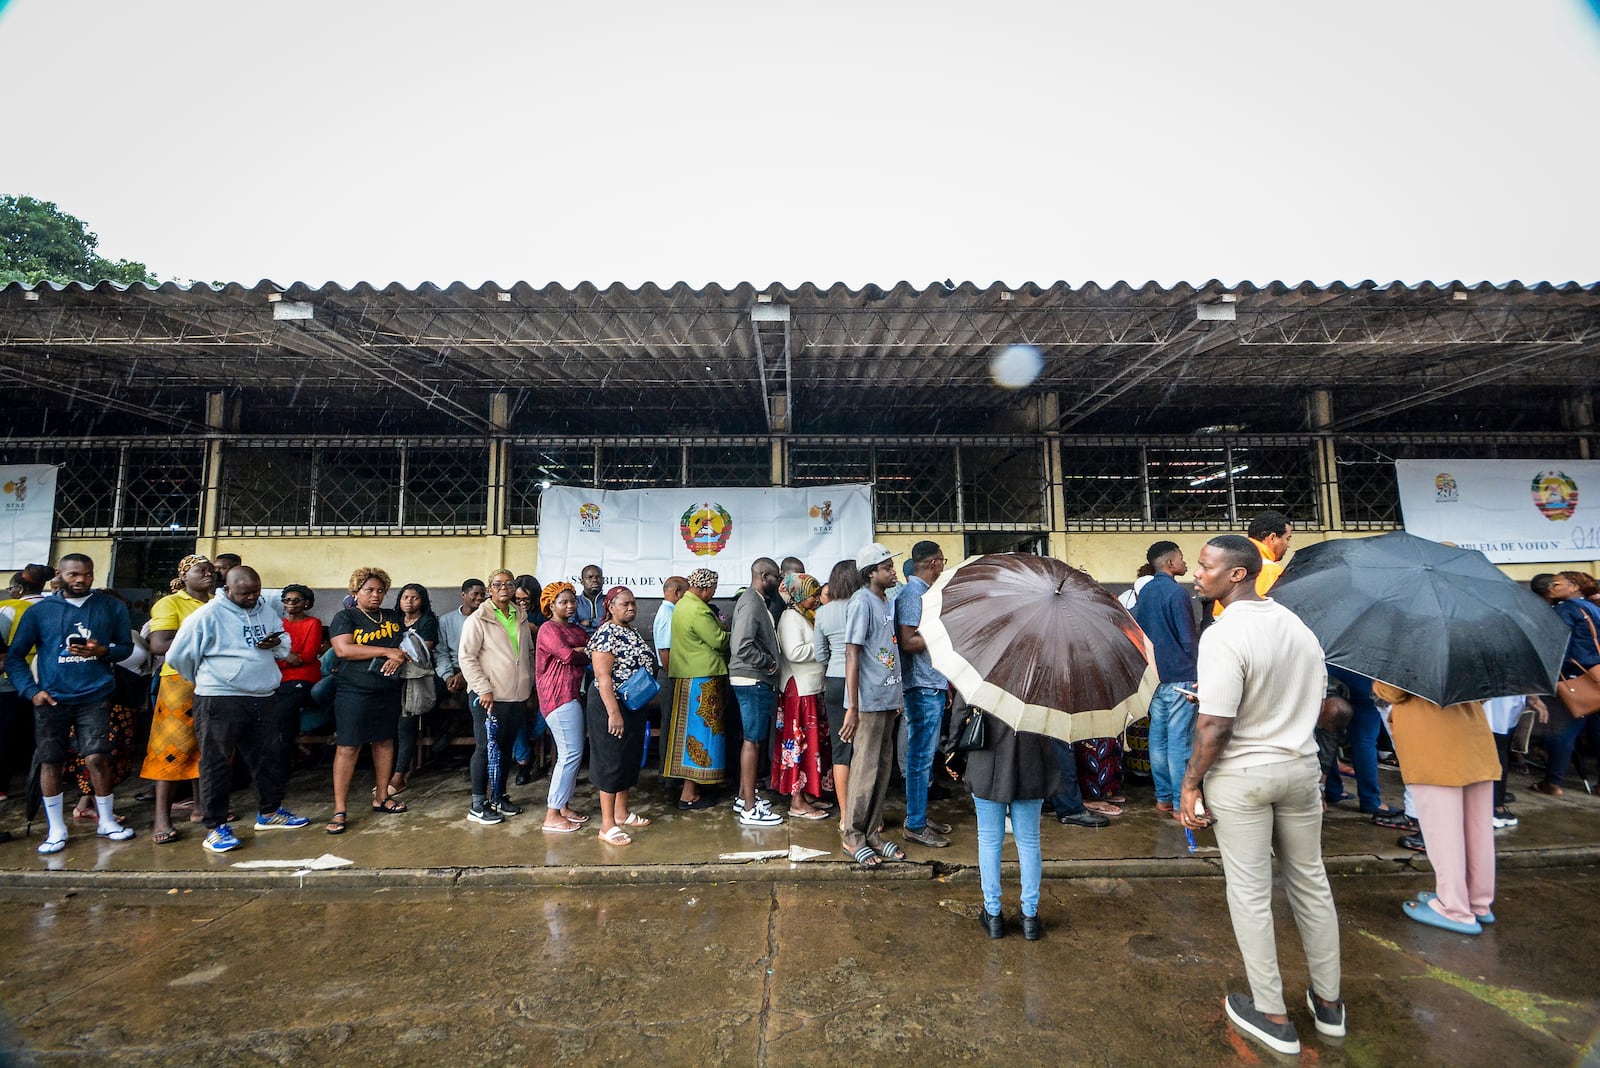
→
(328, 568, 410, 835)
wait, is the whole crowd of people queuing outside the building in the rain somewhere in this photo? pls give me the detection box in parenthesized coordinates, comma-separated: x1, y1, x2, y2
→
(0, 512, 1600, 1052)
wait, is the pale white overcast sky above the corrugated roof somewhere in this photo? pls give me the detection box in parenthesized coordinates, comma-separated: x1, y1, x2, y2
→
(0, 0, 1600, 286)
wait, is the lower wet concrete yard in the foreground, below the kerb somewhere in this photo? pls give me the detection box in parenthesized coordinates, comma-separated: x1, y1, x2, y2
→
(0, 868, 1600, 1068)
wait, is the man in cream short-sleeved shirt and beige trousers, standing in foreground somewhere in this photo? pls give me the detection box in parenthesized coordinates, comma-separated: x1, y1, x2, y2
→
(1179, 534, 1344, 1054)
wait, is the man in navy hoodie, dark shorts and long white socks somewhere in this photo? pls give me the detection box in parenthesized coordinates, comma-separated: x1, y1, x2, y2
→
(5, 553, 133, 854)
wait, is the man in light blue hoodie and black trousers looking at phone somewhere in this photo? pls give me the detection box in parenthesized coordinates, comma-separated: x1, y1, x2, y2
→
(166, 564, 309, 852)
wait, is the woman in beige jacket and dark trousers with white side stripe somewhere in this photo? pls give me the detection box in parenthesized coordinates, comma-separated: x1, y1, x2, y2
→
(456, 571, 534, 825)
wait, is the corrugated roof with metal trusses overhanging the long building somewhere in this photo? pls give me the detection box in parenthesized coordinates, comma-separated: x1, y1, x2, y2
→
(0, 280, 1600, 433)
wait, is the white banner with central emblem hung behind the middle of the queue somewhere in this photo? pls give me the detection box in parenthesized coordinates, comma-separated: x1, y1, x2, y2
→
(536, 484, 872, 596)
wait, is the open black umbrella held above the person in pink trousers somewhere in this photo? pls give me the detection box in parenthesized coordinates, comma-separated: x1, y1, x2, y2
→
(1270, 531, 1566, 705)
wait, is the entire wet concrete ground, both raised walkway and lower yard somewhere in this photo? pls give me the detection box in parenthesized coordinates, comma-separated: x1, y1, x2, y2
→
(0, 754, 1600, 1066)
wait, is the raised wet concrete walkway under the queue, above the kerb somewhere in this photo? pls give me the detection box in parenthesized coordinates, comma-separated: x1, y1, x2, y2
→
(0, 757, 1600, 889)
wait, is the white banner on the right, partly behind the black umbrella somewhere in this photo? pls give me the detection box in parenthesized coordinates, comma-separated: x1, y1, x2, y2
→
(1395, 460, 1600, 564)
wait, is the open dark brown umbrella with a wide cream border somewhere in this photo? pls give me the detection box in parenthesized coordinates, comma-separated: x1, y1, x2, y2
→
(920, 553, 1158, 742)
